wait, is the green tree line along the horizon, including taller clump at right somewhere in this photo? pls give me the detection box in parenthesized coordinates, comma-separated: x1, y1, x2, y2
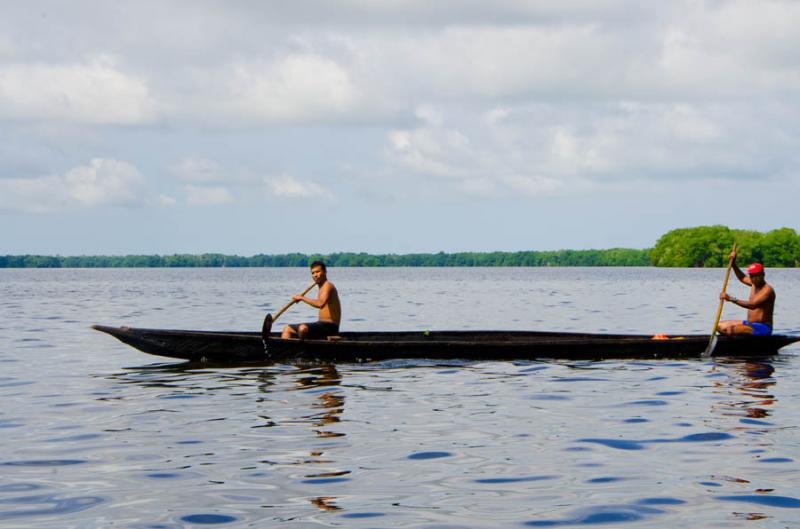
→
(0, 226, 800, 268)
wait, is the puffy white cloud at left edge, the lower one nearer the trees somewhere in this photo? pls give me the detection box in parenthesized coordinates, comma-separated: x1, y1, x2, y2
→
(0, 158, 146, 213)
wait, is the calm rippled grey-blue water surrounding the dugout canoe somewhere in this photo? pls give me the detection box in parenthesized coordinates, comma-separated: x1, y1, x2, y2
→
(0, 268, 800, 529)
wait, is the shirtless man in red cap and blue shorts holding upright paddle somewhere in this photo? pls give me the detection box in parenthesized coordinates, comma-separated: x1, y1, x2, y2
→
(719, 250, 775, 336)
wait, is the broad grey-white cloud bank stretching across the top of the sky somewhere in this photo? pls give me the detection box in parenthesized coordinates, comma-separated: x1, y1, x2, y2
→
(0, 0, 800, 128)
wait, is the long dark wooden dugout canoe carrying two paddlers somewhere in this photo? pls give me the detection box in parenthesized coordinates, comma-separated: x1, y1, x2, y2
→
(93, 325, 800, 363)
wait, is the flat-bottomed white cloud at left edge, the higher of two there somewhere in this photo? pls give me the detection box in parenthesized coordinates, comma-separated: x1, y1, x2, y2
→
(0, 56, 156, 125)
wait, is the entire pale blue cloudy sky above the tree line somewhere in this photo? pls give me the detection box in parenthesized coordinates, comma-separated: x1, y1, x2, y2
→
(0, 0, 800, 256)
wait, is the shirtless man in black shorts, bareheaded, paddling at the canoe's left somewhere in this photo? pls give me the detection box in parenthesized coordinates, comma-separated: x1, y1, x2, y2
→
(281, 261, 342, 340)
